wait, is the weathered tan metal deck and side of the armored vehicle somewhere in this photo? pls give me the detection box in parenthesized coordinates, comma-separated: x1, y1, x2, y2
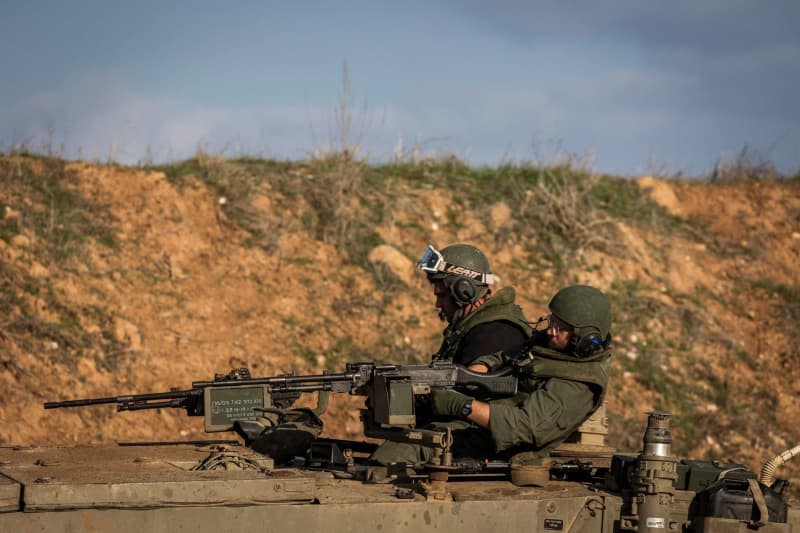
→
(0, 444, 800, 533)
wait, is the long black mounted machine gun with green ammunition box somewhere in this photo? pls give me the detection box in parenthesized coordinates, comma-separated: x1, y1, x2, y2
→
(44, 361, 517, 438)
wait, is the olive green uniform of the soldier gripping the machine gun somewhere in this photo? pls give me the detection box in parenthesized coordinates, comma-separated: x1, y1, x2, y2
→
(372, 336, 610, 464)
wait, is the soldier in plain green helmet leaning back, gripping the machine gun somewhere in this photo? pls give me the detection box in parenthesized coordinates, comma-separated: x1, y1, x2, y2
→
(373, 285, 611, 474)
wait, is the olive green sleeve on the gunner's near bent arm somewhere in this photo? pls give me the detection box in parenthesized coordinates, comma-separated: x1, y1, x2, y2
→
(489, 378, 594, 452)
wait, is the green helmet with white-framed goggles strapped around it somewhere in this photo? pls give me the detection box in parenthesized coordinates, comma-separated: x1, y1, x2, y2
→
(417, 243, 495, 307)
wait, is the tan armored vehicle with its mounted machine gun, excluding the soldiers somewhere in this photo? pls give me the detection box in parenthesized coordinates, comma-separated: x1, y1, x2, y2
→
(0, 363, 800, 533)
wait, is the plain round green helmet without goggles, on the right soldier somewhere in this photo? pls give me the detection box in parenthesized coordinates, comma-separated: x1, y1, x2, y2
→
(549, 285, 612, 356)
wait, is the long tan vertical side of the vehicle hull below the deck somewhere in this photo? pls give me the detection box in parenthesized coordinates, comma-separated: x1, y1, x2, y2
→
(0, 501, 611, 533)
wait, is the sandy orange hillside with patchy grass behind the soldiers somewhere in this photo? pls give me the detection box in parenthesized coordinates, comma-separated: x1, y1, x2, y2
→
(0, 151, 800, 486)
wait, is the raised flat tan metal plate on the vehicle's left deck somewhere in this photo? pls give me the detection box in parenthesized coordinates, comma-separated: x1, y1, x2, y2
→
(0, 445, 315, 511)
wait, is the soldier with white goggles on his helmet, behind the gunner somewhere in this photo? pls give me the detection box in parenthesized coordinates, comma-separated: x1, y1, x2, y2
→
(417, 244, 531, 365)
